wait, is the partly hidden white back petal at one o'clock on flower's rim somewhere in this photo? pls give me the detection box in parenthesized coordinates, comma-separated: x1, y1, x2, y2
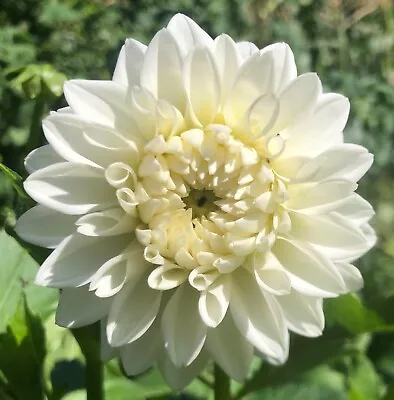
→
(261, 43, 297, 93)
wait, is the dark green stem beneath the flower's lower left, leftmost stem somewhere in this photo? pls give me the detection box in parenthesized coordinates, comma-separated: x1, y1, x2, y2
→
(72, 323, 104, 400)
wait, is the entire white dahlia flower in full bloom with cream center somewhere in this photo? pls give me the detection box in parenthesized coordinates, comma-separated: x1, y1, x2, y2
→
(16, 14, 375, 388)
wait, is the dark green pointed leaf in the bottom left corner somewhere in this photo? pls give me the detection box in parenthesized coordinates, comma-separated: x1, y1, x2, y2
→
(0, 294, 45, 400)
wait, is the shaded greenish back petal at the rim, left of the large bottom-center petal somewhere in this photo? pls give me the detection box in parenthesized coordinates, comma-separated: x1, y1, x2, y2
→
(120, 322, 160, 376)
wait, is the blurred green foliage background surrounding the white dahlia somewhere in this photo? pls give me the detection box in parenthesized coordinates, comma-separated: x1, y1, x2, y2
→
(0, 0, 394, 400)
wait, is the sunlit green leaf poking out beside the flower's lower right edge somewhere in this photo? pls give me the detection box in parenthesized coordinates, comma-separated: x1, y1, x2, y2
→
(325, 294, 394, 334)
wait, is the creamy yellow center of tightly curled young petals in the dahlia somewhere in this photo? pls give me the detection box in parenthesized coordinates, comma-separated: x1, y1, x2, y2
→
(106, 120, 290, 290)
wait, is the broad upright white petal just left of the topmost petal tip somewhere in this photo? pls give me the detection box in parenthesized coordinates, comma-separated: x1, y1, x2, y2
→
(141, 29, 185, 110)
